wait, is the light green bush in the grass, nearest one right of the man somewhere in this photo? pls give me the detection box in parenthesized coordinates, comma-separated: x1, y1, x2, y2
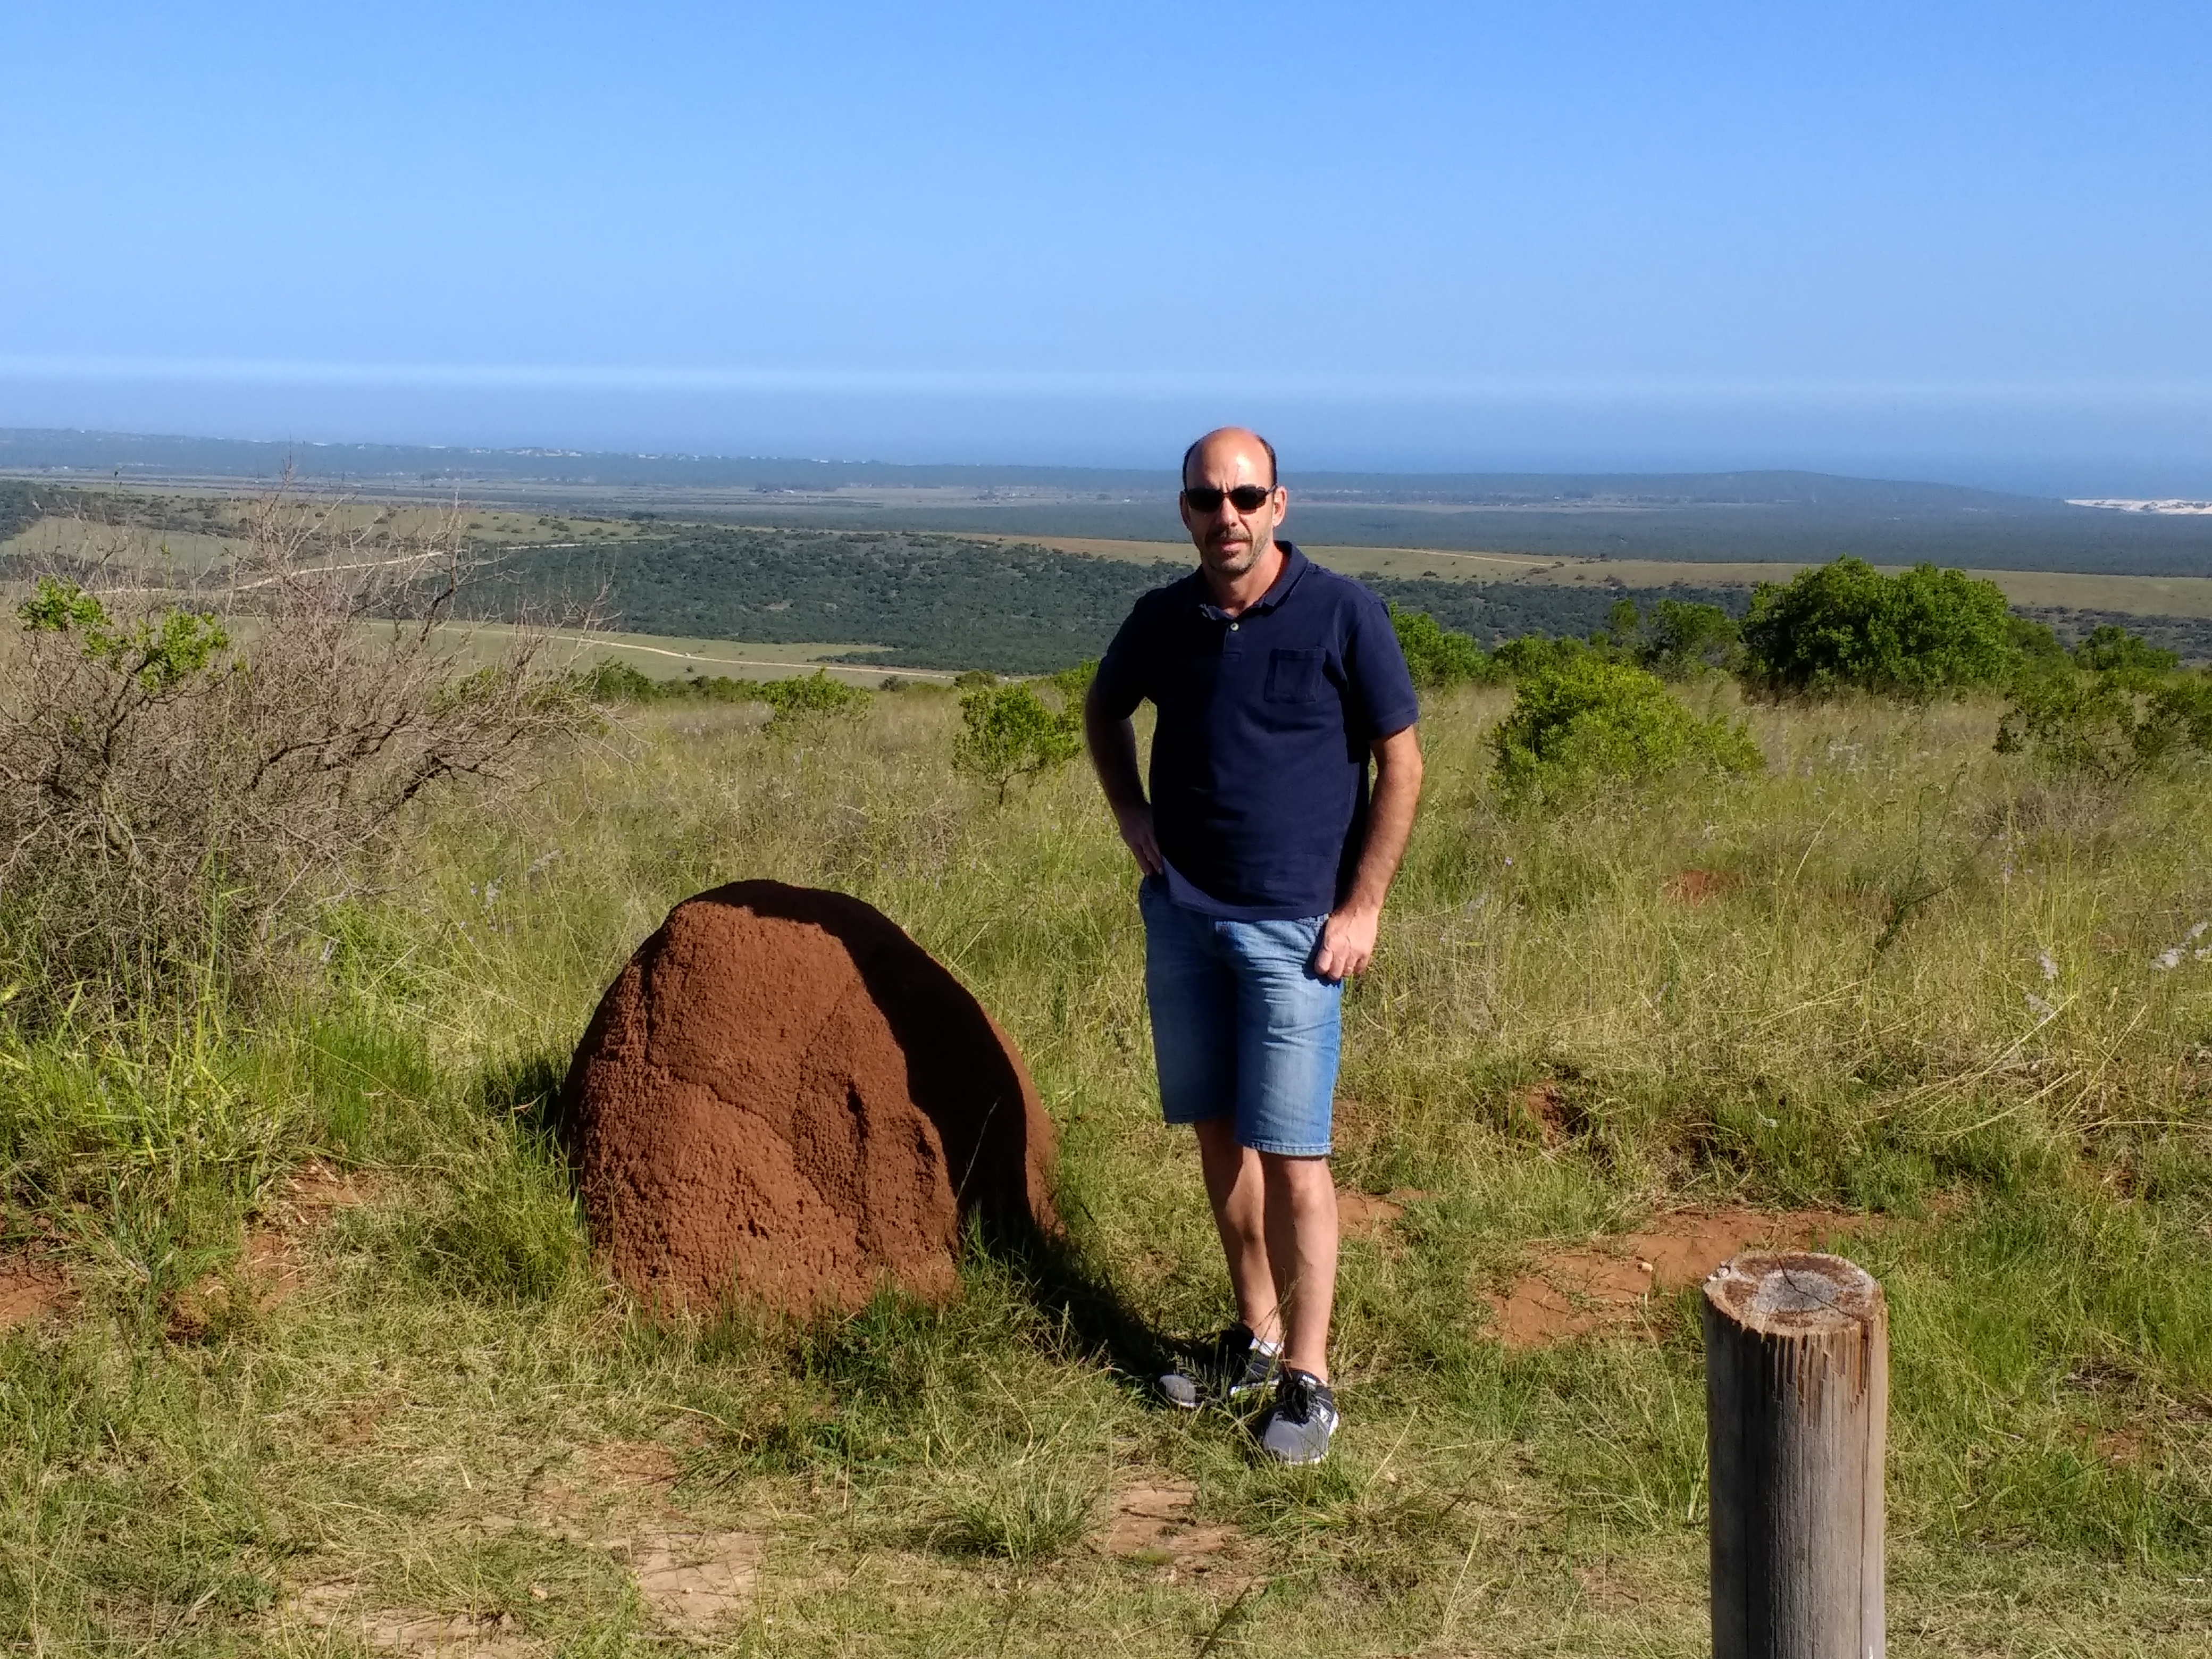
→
(1491, 652, 1763, 794)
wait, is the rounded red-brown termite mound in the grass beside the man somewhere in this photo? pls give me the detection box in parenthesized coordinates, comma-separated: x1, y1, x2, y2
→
(562, 881, 1057, 1312)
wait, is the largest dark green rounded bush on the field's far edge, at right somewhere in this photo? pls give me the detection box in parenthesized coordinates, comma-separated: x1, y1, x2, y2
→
(1743, 557, 2020, 697)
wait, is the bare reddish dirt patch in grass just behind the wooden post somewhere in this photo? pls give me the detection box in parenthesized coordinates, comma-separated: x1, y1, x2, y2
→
(1489, 1210, 1871, 1347)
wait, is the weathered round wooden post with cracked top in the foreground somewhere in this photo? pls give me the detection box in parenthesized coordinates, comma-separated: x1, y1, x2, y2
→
(1705, 1252, 1889, 1659)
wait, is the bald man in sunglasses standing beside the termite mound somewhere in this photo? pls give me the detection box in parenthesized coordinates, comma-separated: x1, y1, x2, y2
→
(1084, 427, 1420, 1464)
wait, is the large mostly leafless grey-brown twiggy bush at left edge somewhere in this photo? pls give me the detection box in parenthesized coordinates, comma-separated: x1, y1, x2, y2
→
(0, 489, 589, 1002)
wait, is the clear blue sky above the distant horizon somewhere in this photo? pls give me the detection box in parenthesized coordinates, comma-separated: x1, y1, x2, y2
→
(0, 0, 2212, 493)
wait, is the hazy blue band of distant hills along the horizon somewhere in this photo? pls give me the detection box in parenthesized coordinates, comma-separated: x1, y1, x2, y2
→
(0, 429, 2212, 575)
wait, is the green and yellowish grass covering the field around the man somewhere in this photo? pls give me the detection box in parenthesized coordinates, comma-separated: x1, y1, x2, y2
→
(0, 692, 2212, 1657)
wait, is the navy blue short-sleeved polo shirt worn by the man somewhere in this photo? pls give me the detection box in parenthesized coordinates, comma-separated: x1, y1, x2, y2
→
(1093, 542, 1420, 923)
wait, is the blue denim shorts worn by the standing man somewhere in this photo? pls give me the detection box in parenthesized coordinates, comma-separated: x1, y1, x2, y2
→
(1137, 876, 1345, 1157)
